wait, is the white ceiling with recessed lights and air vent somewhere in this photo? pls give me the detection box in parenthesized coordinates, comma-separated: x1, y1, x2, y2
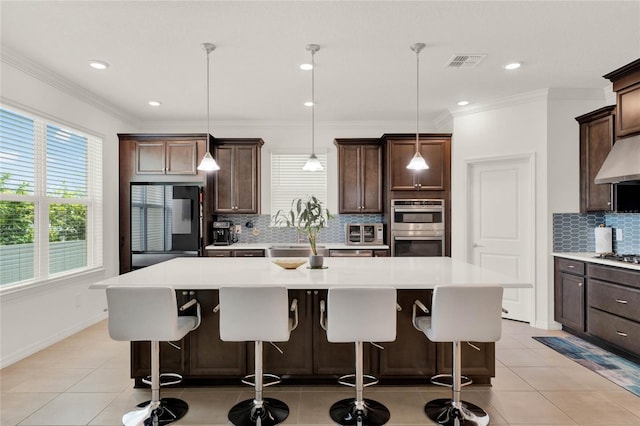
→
(0, 0, 640, 123)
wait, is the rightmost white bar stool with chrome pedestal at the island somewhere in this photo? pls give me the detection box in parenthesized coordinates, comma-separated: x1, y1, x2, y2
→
(413, 285, 503, 425)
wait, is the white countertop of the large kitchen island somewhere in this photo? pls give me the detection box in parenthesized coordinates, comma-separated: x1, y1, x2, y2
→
(90, 257, 531, 290)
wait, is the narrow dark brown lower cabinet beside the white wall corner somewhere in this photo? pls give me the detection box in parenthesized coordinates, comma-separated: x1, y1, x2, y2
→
(554, 257, 586, 331)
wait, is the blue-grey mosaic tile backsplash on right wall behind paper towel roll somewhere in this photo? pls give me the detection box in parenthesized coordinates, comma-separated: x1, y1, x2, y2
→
(553, 213, 640, 254)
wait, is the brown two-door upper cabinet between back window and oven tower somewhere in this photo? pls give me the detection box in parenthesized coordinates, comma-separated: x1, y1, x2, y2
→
(334, 139, 383, 213)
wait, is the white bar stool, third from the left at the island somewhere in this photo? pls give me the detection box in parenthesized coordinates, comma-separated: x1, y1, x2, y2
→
(320, 287, 397, 426)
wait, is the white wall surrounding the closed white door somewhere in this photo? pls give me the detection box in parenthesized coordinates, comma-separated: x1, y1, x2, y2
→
(451, 89, 604, 329)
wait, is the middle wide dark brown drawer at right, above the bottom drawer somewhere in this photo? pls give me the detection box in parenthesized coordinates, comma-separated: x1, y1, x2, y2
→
(587, 278, 640, 322)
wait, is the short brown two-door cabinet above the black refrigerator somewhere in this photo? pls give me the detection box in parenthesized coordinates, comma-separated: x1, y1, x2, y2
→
(135, 140, 198, 175)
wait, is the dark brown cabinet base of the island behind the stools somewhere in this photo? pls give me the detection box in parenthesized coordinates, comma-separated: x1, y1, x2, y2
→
(131, 290, 495, 386)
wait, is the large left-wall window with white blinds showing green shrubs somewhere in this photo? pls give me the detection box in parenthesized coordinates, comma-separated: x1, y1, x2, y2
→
(0, 107, 102, 287)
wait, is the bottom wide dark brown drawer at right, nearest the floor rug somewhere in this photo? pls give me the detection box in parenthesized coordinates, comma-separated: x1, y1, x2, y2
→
(587, 308, 640, 354)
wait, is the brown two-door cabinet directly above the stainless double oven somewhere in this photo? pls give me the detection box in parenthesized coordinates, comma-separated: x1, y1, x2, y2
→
(383, 134, 451, 191)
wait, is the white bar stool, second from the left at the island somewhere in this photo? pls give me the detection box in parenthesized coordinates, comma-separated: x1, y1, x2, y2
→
(219, 287, 298, 426)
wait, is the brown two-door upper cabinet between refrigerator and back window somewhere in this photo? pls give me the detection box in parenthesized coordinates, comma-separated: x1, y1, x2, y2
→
(213, 138, 264, 214)
